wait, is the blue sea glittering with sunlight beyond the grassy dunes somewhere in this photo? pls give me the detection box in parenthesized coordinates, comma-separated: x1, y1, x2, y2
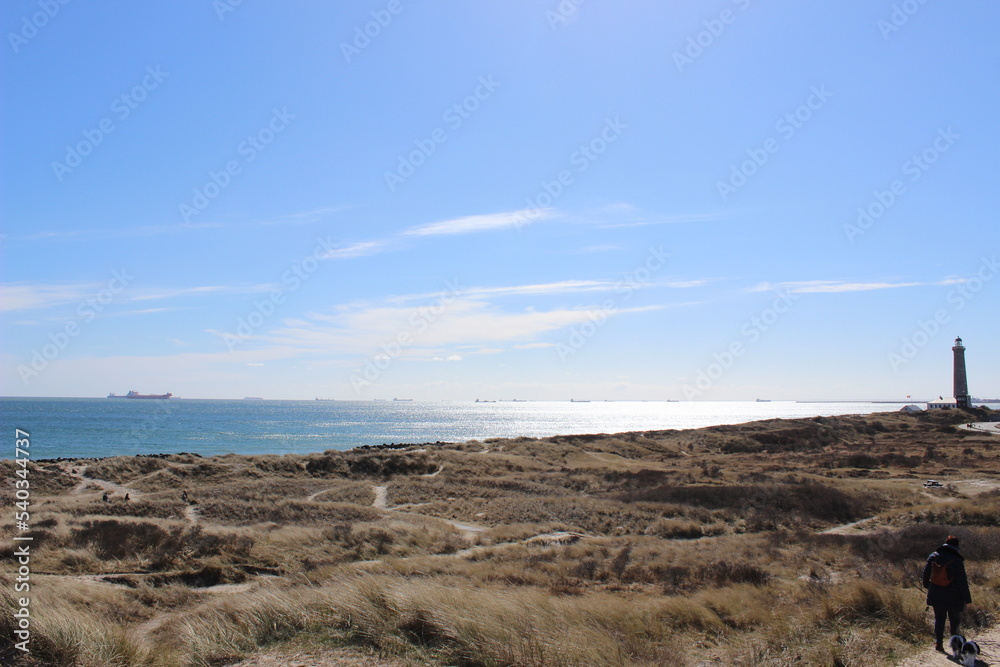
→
(0, 398, 960, 459)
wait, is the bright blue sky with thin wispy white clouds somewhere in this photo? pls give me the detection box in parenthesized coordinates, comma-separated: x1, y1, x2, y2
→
(0, 0, 1000, 400)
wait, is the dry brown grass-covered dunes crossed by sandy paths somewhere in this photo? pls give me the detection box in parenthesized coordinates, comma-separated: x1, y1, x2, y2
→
(0, 415, 1000, 667)
